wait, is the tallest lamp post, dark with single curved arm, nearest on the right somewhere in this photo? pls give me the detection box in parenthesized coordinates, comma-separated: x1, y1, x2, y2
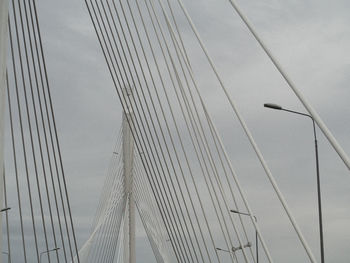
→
(264, 103, 325, 263)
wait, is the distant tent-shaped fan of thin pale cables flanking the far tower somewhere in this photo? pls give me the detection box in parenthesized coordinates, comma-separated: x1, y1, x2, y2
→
(79, 118, 171, 262)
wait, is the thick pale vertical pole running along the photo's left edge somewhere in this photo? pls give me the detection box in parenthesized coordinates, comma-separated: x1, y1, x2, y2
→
(0, 0, 8, 263)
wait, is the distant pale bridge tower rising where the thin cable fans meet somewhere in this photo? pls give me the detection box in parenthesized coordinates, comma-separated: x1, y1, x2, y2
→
(123, 112, 136, 263)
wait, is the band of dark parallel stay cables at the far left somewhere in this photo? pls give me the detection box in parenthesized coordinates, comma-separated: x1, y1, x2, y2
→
(2, 0, 79, 262)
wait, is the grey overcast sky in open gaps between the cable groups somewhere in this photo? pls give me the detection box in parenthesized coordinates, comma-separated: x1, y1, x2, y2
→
(3, 0, 350, 263)
